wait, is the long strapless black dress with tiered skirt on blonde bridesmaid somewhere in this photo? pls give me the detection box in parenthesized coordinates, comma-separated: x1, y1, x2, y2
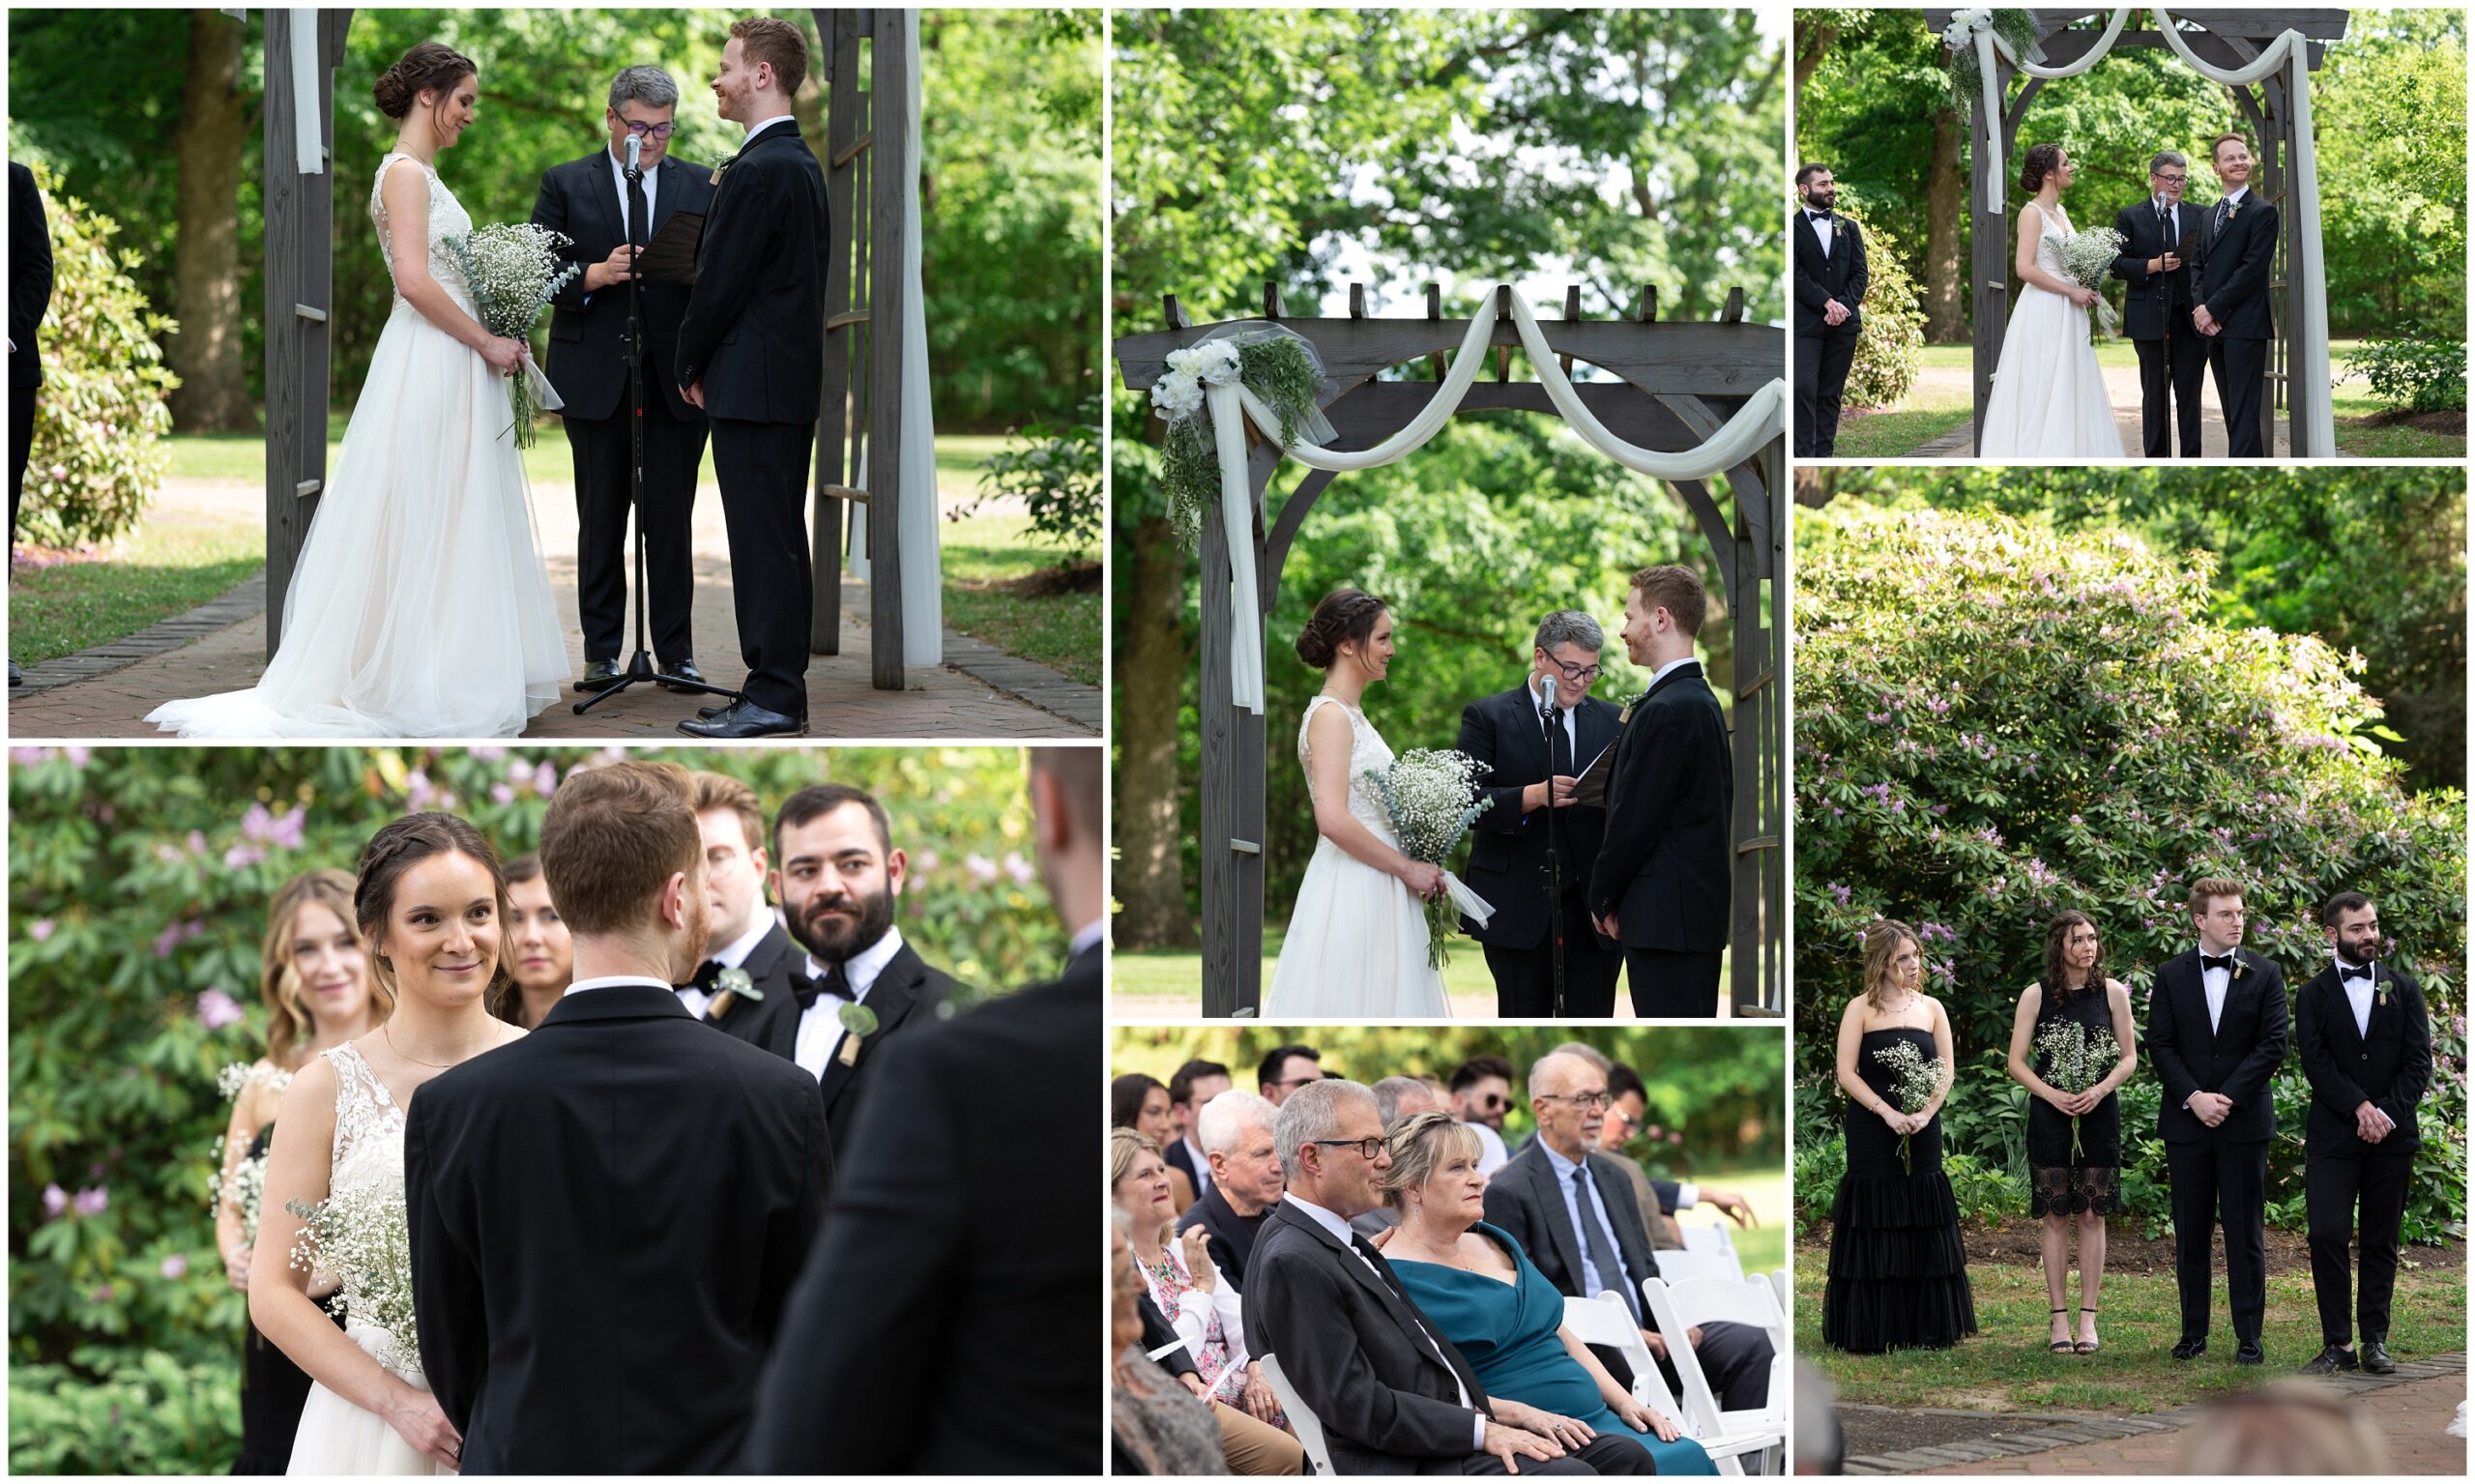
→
(1821, 1027, 1977, 1355)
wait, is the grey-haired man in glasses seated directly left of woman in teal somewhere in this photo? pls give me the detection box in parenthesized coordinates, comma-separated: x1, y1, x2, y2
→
(1245, 1078, 1656, 1474)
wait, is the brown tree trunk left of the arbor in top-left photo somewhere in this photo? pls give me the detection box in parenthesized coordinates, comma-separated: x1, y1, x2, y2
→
(166, 10, 250, 433)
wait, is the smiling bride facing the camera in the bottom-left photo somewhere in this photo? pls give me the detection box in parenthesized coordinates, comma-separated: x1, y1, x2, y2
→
(250, 814, 525, 1474)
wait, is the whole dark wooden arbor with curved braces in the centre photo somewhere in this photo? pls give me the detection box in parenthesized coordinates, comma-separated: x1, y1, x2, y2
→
(1117, 284, 1787, 1016)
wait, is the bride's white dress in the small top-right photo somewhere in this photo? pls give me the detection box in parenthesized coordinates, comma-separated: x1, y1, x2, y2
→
(1977, 208, 2123, 457)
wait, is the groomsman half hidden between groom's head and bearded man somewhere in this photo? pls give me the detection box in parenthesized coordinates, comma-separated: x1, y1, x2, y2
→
(678, 771, 807, 1046)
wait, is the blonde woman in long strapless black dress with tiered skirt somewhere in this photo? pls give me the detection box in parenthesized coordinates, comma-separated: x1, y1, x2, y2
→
(1821, 920, 1977, 1355)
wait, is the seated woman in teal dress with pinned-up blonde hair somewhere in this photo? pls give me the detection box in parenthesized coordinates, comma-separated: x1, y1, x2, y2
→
(1379, 1113, 1718, 1474)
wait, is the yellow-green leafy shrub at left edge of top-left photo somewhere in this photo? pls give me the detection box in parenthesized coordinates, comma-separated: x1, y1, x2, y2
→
(19, 163, 181, 546)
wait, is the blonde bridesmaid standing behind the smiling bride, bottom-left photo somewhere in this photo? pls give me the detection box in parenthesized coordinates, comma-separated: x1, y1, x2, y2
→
(216, 871, 386, 1474)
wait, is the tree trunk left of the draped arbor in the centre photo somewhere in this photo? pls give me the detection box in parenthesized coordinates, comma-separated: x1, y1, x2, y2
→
(1114, 514, 1195, 947)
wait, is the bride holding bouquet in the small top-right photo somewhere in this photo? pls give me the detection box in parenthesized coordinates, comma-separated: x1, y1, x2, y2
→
(1977, 143, 2123, 457)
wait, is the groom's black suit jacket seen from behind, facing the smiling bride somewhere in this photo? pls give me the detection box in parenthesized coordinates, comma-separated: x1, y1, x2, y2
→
(403, 984, 834, 1474)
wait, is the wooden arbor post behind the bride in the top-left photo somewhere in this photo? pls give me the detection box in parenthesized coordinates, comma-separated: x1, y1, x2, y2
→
(262, 10, 352, 660)
